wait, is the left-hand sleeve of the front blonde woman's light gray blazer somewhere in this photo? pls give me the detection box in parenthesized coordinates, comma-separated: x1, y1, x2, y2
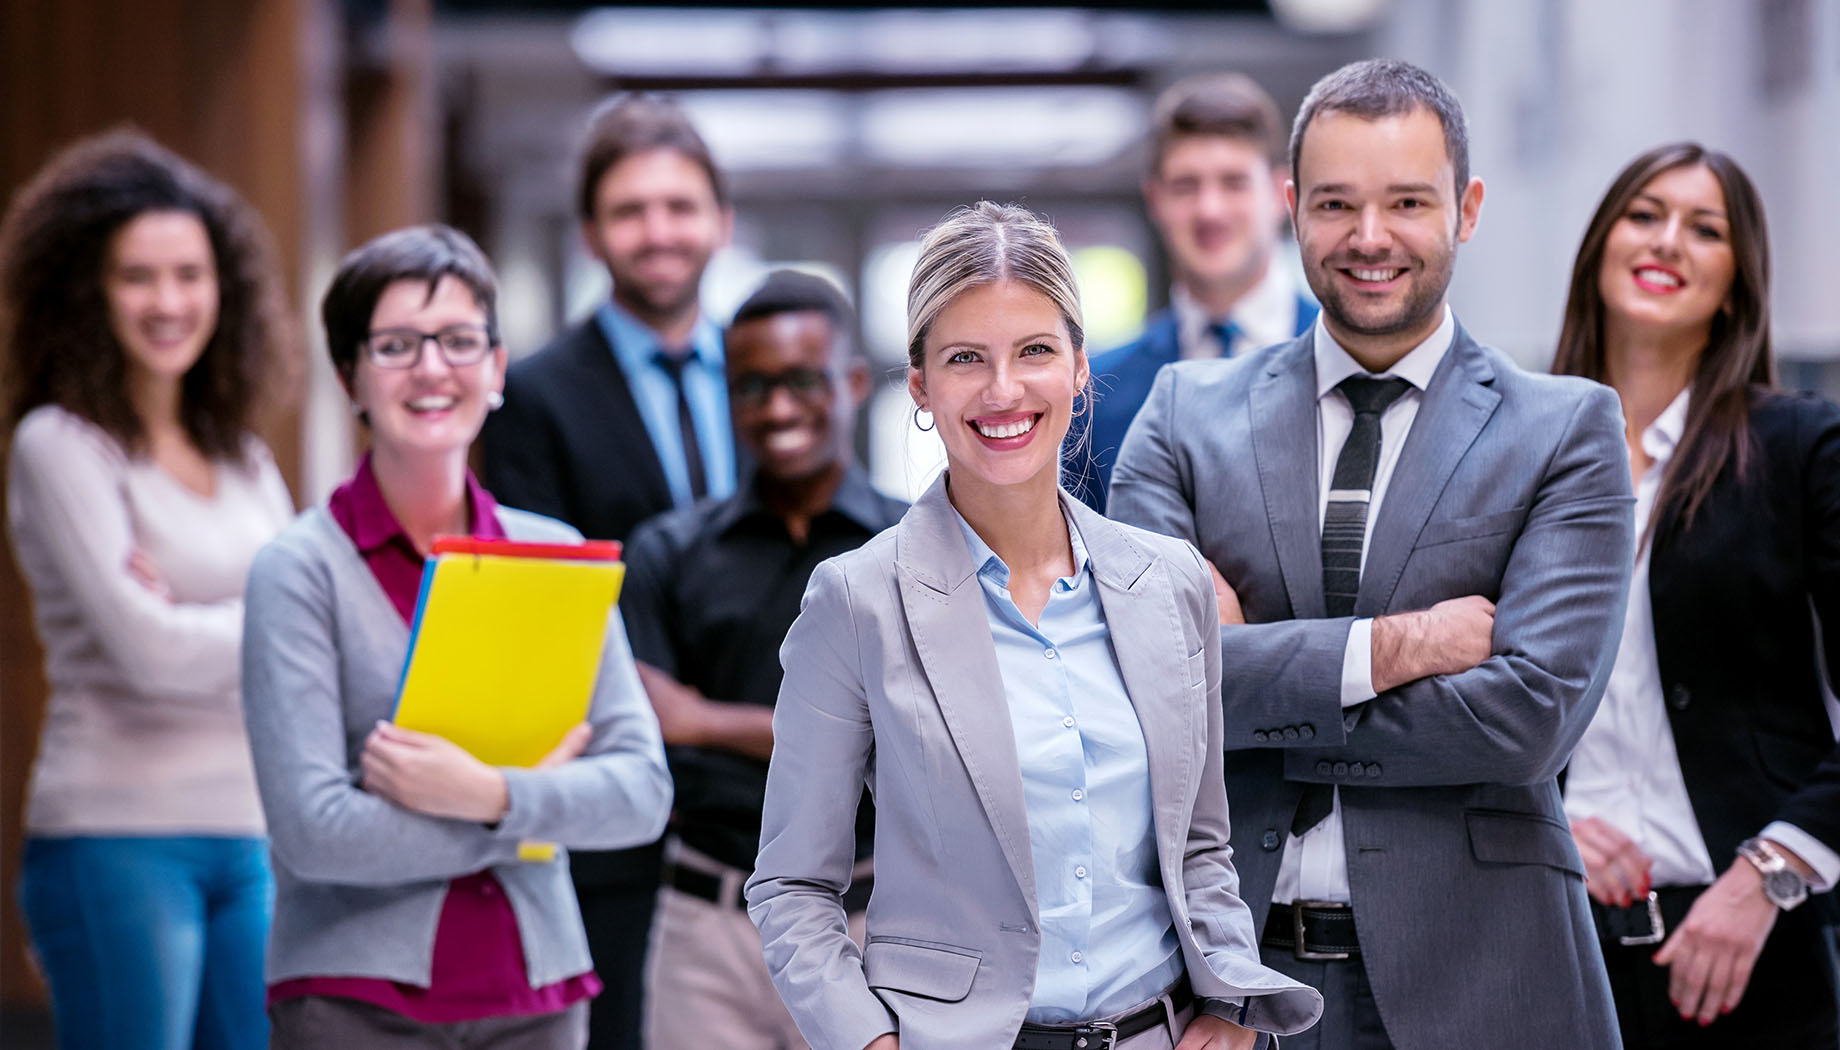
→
(747, 561, 896, 1050)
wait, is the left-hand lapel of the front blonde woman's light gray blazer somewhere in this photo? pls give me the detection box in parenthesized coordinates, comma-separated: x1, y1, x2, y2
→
(894, 474, 1045, 901)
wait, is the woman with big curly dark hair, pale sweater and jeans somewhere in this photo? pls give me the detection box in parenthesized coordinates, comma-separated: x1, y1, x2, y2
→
(0, 132, 294, 1050)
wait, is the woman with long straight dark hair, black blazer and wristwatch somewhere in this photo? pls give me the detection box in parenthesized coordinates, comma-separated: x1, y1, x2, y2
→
(1553, 143, 1840, 1050)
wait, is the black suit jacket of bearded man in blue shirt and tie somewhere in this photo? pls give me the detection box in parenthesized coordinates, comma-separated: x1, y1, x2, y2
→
(480, 316, 672, 541)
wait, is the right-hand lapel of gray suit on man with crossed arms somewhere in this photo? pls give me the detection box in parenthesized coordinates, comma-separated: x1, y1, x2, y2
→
(1361, 325, 1501, 616)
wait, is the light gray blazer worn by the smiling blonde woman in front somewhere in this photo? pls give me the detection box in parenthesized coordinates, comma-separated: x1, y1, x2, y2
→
(747, 478, 1321, 1050)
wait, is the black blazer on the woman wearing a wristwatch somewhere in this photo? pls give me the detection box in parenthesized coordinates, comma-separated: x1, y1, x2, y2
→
(1649, 390, 1840, 916)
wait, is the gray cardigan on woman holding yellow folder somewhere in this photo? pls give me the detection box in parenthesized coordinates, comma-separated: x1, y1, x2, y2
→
(243, 508, 672, 987)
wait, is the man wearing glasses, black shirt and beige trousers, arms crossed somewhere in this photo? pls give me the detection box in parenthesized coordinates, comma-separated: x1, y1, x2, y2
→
(620, 270, 907, 1050)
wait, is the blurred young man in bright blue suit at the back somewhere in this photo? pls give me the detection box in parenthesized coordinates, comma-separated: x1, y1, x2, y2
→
(1062, 74, 1316, 511)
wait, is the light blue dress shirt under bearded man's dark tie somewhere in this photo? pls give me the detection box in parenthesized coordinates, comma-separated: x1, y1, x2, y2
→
(594, 303, 734, 508)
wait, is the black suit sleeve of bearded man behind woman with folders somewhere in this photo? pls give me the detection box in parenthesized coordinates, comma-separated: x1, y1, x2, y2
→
(480, 359, 580, 522)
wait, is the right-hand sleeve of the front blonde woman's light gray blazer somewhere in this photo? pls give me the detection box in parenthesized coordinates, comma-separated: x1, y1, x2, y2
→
(1174, 544, 1323, 1035)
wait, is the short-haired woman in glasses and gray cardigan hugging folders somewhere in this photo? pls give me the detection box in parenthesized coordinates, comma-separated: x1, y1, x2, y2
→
(243, 226, 672, 1050)
